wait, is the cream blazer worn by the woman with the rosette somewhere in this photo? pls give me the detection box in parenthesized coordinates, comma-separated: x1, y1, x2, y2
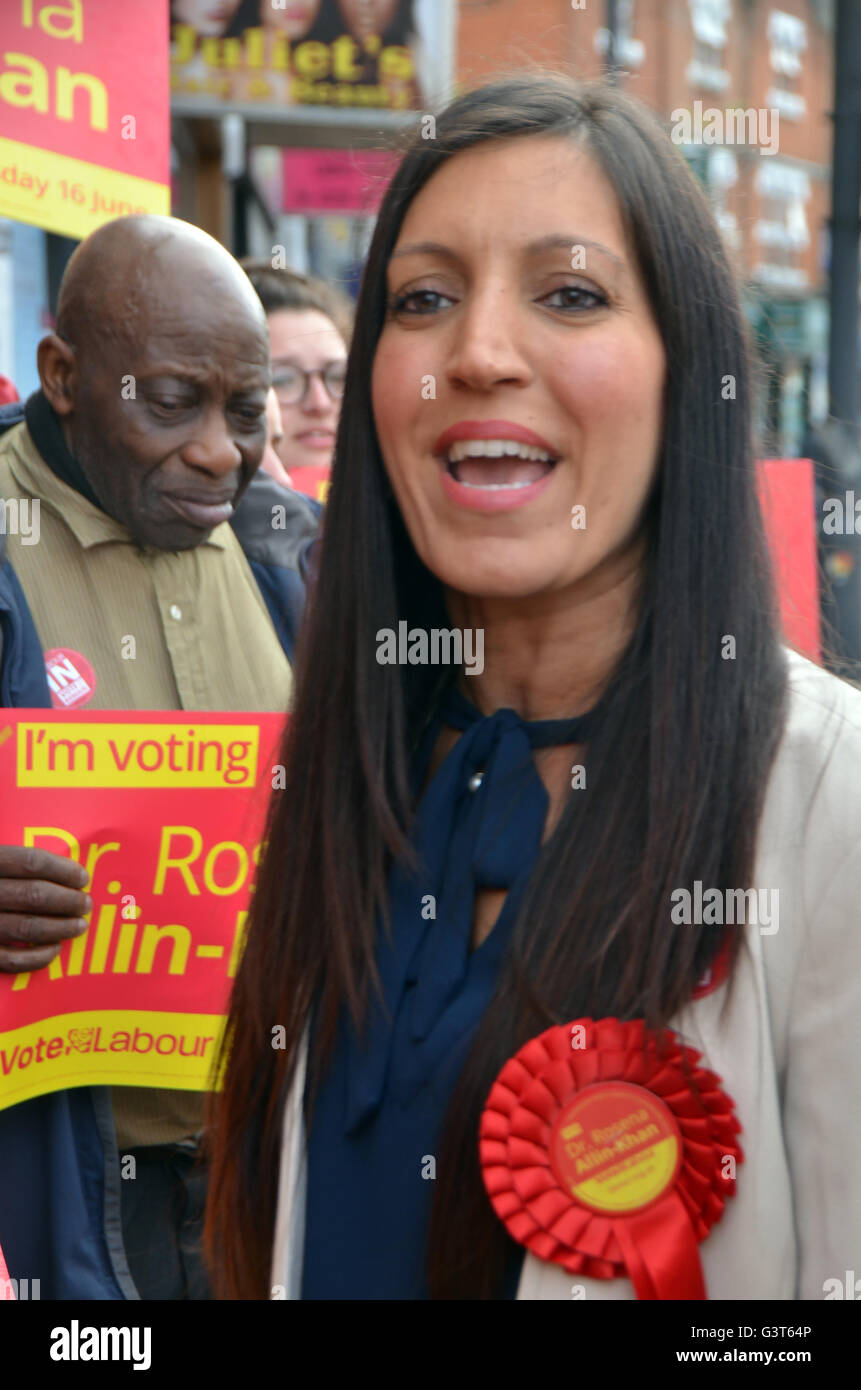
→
(271, 652, 861, 1301)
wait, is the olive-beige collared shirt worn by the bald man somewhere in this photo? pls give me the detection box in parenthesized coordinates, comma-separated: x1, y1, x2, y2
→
(0, 424, 292, 1151)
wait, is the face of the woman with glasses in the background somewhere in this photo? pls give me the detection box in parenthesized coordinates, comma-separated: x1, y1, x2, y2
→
(268, 309, 346, 473)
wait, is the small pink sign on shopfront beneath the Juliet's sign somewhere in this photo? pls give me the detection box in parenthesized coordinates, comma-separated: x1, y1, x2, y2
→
(284, 150, 398, 214)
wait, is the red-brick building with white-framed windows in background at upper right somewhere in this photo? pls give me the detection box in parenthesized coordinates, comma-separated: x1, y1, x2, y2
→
(456, 0, 833, 456)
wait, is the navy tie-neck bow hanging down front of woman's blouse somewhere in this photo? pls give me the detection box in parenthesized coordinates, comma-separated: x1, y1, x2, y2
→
(345, 688, 597, 1133)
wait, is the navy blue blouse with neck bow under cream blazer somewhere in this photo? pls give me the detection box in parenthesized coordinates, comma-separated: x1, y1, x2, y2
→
(302, 689, 597, 1300)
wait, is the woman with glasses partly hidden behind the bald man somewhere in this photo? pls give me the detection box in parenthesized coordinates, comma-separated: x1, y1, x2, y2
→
(243, 260, 352, 496)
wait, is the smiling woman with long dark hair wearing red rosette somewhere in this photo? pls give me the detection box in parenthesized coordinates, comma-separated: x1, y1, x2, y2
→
(207, 76, 861, 1300)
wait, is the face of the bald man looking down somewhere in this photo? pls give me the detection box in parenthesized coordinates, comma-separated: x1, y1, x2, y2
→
(67, 274, 270, 550)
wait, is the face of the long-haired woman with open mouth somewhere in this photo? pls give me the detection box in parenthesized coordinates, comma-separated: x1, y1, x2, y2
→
(371, 136, 666, 599)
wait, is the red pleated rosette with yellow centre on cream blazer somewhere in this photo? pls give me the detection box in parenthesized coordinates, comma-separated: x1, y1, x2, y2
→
(480, 1019, 744, 1300)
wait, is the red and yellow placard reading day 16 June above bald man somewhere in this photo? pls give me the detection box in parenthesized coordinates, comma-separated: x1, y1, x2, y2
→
(0, 0, 170, 236)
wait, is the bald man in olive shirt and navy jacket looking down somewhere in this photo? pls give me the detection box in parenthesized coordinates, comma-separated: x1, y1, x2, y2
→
(0, 217, 317, 1298)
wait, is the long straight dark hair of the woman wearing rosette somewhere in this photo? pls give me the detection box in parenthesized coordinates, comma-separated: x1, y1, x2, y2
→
(207, 74, 786, 1298)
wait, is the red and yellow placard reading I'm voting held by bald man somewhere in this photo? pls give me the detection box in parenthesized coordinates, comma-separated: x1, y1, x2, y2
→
(0, 710, 284, 1108)
